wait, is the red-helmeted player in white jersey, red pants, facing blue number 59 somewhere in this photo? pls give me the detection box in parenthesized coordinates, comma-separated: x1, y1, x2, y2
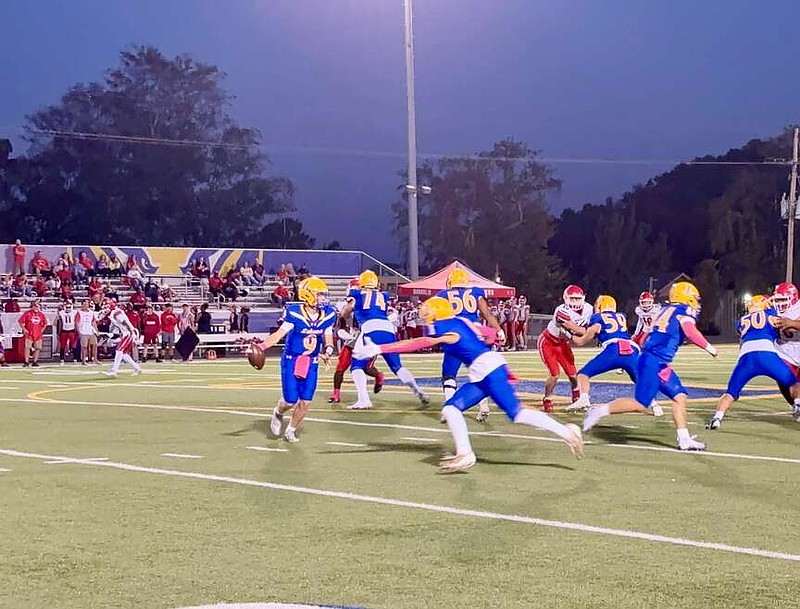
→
(538, 285, 592, 412)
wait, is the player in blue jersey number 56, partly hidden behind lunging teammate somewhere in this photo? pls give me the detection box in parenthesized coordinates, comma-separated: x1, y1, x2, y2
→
(436, 267, 506, 423)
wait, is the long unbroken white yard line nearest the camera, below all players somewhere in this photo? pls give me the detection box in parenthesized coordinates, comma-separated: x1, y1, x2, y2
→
(0, 449, 800, 562)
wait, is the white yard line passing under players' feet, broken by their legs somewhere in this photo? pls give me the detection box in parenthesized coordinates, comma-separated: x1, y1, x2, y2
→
(0, 398, 800, 465)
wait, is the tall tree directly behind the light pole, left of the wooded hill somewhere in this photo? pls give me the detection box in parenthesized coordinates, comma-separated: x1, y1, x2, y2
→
(393, 139, 562, 308)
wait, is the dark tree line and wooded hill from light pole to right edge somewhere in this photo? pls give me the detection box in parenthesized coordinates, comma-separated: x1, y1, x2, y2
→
(393, 128, 792, 323)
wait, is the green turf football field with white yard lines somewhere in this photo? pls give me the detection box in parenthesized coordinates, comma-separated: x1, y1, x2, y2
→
(0, 346, 800, 609)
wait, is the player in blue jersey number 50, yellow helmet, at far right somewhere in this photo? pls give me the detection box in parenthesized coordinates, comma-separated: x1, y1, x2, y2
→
(706, 295, 800, 429)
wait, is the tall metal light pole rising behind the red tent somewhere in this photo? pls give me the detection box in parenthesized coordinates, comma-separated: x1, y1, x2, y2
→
(404, 0, 419, 279)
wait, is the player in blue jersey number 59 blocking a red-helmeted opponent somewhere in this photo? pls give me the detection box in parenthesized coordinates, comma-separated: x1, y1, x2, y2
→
(563, 294, 663, 416)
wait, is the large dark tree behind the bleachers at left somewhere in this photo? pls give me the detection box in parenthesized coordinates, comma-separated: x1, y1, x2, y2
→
(2, 46, 302, 247)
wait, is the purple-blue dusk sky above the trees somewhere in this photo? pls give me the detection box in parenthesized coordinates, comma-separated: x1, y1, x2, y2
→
(0, 0, 800, 261)
